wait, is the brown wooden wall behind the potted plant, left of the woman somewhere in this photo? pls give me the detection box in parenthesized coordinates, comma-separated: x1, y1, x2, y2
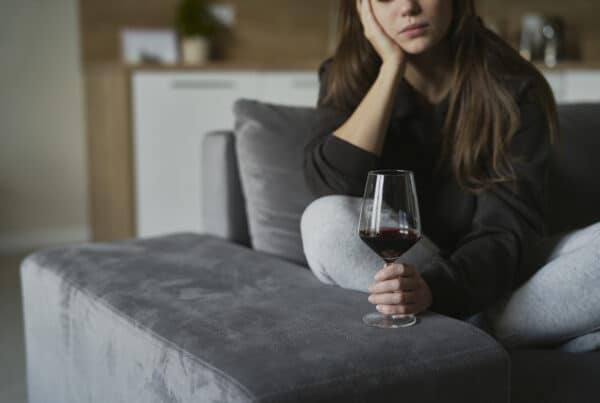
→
(80, 0, 337, 66)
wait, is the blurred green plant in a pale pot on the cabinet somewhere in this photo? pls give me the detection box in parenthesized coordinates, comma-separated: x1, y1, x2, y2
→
(175, 0, 221, 64)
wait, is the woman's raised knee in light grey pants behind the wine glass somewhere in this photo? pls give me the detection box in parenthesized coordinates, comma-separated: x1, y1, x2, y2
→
(300, 195, 437, 292)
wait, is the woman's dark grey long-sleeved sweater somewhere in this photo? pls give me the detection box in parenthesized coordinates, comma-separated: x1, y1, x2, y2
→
(304, 62, 550, 318)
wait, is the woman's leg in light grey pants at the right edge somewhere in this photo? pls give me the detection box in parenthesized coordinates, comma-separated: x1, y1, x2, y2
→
(485, 224, 600, 347)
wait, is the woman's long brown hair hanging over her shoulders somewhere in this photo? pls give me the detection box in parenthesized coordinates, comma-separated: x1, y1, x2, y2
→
(322, 0, 559, 192)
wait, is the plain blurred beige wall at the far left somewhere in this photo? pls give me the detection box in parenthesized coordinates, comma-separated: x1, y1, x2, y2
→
(0, 0, 89, 252)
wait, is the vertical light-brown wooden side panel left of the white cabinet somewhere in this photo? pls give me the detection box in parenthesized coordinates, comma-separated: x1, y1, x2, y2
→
(85, 65, 135, 241)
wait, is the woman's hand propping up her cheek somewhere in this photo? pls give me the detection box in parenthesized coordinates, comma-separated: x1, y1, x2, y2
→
(356, 0, 405, 65)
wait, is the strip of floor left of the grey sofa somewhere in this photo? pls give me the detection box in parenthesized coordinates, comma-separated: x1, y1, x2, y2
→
(0, 255, 27, 403)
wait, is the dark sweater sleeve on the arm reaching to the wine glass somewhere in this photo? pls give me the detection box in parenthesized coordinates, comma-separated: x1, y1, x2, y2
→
(422, 89, 550, 318)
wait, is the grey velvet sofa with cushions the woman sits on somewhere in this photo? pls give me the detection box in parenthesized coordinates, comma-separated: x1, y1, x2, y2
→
(21, 101, 600, 403)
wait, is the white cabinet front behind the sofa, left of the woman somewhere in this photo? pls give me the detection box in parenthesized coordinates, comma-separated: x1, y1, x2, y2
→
(132, 71, 318, 236)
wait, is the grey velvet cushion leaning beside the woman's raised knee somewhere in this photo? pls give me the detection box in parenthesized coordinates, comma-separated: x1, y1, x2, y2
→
(234, 99, 315, 264)
